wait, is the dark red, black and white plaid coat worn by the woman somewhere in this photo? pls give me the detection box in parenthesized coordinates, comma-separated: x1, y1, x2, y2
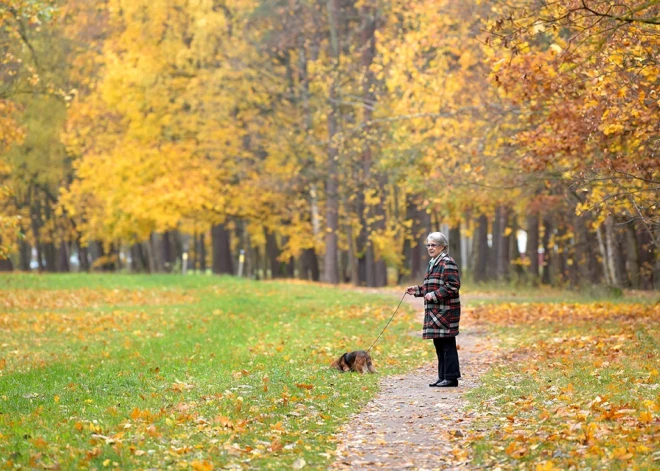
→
(413, 253, 461, 339)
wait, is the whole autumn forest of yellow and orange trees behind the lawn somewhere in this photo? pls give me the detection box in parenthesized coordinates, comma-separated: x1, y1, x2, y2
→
(0, 0, 660, 289)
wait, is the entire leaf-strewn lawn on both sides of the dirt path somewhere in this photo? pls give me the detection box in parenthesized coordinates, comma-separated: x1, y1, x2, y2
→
(0, 274, 660, 470)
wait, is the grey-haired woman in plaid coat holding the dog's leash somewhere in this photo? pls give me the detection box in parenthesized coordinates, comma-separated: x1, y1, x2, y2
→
(406, 232, 461, 388)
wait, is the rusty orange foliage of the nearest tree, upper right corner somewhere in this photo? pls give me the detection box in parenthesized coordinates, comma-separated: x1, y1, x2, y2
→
(488, 0, 660, 240)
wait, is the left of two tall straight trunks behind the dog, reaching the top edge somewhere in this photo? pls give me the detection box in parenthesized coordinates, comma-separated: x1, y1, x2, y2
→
(323, 0, 340, 284)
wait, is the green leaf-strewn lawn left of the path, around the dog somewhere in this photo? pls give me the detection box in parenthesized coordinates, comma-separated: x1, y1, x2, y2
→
(0, 274, 430, 470)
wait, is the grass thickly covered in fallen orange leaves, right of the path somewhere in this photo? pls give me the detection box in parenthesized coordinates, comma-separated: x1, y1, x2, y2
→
(468, 297, 660, 471)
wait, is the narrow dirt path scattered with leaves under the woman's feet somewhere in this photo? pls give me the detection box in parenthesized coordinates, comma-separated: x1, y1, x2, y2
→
(331, 297, 492, 470)
